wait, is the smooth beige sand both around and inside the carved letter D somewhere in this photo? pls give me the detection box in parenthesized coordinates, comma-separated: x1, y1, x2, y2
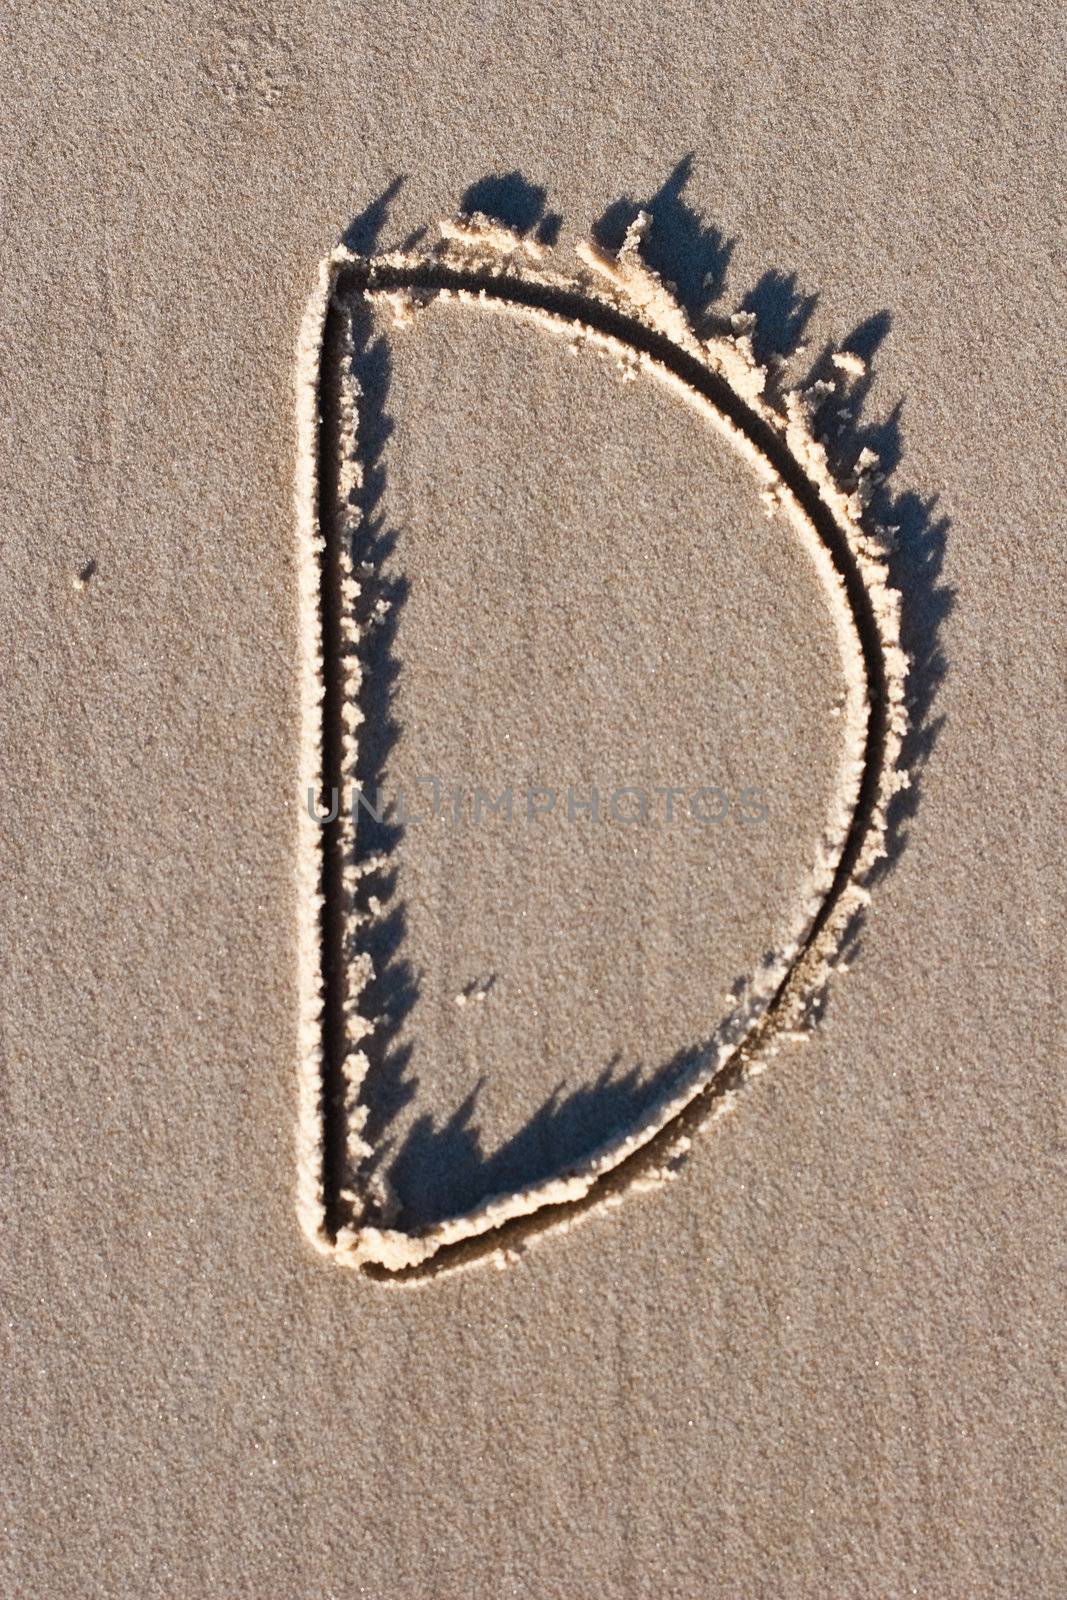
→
(0, 6, 1067, 1600)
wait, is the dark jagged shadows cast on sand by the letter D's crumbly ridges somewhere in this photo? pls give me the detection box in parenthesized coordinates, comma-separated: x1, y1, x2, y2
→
(329, 157, 953, 1227)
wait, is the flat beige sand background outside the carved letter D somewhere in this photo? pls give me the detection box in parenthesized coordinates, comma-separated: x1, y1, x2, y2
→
(0, 3, 1067, 1600)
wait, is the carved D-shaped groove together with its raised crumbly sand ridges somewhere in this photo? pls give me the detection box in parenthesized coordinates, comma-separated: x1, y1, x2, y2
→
(296, 214, 907, 1282)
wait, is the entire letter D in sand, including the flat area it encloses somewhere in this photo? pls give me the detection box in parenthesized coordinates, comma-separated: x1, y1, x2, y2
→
(296, 228, 910, 1280)
